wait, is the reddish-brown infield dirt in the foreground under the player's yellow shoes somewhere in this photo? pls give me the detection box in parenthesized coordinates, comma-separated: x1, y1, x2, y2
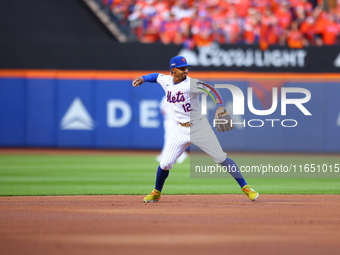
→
(0, 195, 340, 255)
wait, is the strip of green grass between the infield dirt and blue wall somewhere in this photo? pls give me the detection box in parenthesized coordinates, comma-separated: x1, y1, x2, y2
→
(0, 154, 340, 196)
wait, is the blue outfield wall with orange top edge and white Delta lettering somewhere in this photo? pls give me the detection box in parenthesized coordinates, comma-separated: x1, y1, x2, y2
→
(0, 71, 340, 152)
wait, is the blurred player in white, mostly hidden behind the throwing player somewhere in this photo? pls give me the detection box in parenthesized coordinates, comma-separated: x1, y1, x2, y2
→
(156, 96, 188, 164)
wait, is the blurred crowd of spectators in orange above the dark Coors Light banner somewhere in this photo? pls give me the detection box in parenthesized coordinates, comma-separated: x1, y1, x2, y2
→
(102, 0, 340, 49)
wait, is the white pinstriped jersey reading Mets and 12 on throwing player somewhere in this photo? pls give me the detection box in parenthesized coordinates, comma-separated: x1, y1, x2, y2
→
(157, 74, 204, 123)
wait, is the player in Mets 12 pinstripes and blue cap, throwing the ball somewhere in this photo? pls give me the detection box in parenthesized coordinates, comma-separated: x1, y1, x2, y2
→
(132, 56, 259, 203)
